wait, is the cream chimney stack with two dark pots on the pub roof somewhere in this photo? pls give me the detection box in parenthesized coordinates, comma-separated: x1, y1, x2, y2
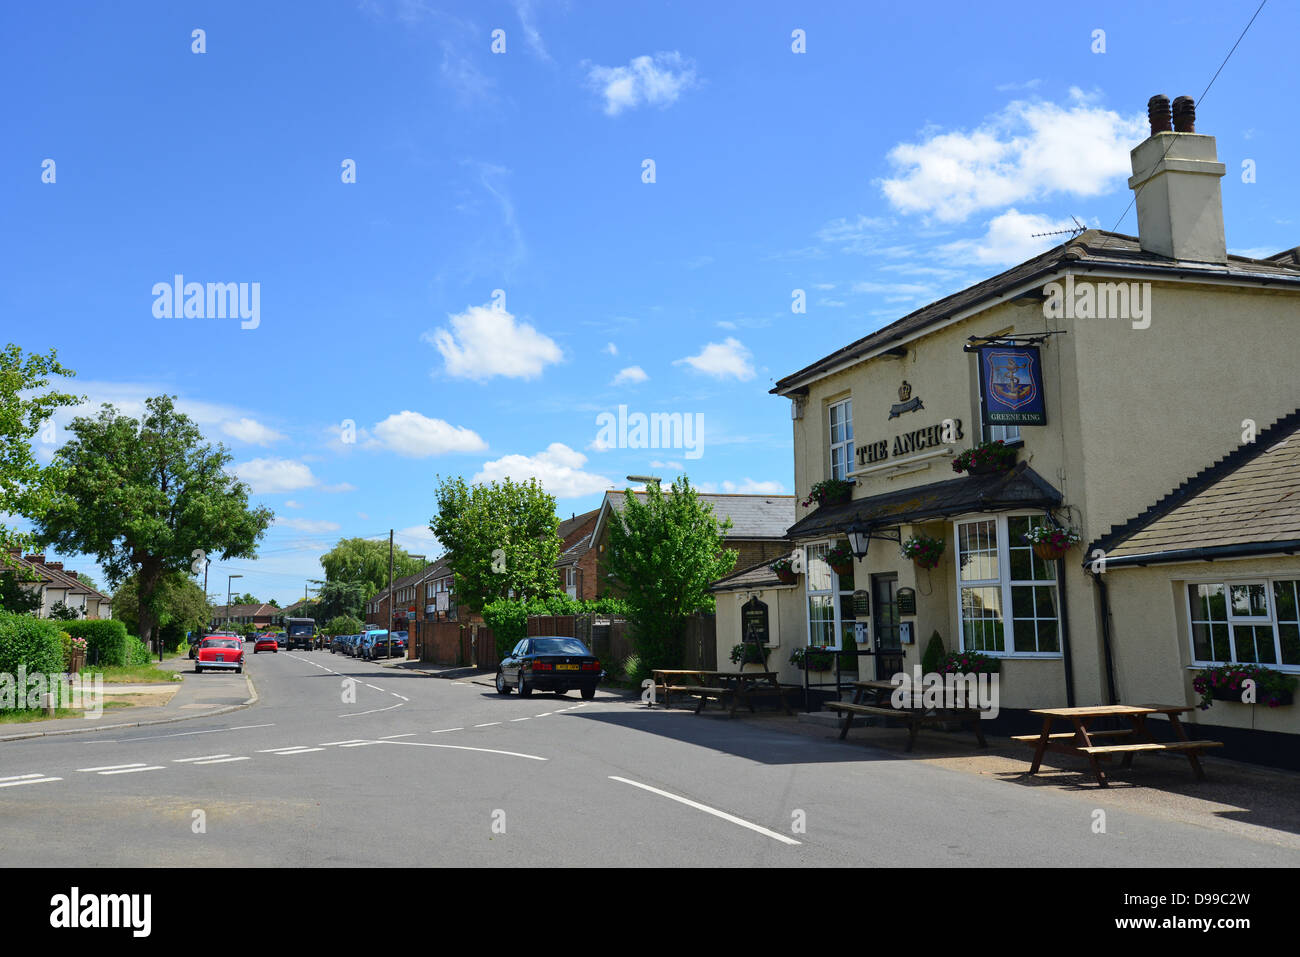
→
(1128, 96, 1227, 263)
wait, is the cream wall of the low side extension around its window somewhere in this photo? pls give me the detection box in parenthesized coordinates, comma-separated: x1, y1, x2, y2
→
(1106, 555, 1300, 733)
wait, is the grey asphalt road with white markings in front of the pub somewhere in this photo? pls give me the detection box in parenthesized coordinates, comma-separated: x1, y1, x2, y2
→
(0, 651, 1297, 867)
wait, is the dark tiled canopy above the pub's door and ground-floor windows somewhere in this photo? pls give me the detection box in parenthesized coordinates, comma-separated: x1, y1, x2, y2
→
(787, 462, 1061, 540)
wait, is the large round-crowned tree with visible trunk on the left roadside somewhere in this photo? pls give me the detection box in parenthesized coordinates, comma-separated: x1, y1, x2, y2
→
(36, 395, 274, 655)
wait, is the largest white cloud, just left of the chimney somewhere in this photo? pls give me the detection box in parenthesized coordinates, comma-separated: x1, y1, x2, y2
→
(880, 88, 1144, 222)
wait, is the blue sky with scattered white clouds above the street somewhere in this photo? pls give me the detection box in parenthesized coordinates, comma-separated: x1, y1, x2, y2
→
(0, 0, 1300, 603)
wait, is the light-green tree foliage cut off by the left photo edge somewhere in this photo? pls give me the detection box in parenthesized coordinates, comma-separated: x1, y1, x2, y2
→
(0, 342, 83, 564)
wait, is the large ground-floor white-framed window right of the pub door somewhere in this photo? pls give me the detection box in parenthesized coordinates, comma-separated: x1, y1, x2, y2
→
(953, 515, 1061, 657)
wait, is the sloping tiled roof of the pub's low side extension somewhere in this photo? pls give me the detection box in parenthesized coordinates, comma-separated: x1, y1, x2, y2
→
(1084, 410, 1300, 567)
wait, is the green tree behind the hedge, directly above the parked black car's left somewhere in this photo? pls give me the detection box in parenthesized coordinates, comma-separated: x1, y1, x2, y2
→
(429, 476, 560, 611)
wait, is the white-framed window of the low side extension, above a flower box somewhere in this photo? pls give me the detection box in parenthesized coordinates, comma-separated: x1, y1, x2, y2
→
(1187, 579, 1300, 667)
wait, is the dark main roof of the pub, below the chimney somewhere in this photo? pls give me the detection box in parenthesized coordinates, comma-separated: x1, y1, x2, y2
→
(770, 229, 1300, 395)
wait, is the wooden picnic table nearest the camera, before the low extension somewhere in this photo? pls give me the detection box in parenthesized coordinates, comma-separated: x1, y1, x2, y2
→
(1011, 705, 1223, 788)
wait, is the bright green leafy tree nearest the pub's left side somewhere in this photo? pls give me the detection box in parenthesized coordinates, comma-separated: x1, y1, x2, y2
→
(603, 476, 737, 668)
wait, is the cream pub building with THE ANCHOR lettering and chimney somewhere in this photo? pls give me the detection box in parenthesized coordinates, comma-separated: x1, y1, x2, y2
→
(714, 96, 1300, 766)
